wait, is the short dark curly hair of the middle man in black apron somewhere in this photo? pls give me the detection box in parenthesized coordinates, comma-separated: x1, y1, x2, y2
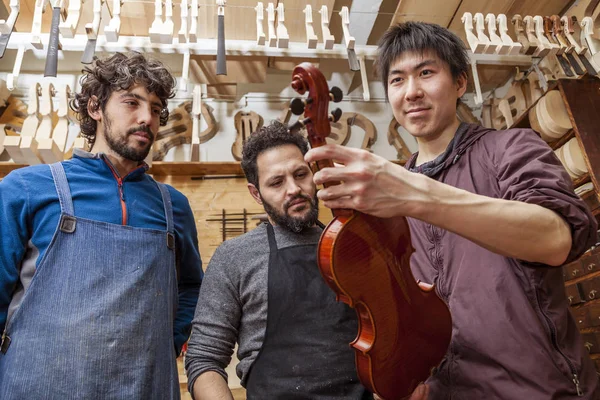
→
(242, 120, 308, 188)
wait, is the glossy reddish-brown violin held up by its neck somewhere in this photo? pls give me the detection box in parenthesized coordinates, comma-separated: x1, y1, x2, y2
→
(290, 63, 452, 400)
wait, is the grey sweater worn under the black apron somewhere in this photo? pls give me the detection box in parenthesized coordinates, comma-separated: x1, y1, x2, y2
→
(185, 224, 322, 393)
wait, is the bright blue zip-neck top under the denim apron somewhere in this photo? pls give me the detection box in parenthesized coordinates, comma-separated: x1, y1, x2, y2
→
(0, 150, 203, 353)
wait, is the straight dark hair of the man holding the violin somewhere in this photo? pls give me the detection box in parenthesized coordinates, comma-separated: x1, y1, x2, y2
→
(375, 21, 470, 98)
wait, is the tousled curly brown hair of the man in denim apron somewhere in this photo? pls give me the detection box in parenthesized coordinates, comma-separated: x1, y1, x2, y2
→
(69, 52, 175, 147)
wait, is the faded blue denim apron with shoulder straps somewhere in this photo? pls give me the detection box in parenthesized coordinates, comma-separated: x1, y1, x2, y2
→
(0, 163, 179, 400)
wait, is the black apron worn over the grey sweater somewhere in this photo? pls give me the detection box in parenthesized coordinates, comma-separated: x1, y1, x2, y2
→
(246, 224, 373, 400)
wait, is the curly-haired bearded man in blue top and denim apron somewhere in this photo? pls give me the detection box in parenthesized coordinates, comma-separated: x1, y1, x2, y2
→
(0, 53, 202, 400)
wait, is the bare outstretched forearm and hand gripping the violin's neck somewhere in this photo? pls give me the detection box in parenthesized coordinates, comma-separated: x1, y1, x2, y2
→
(306, 145, 572, 265)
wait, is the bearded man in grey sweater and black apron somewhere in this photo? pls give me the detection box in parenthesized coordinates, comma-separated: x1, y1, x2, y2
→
(186, 122, 390, 400)
